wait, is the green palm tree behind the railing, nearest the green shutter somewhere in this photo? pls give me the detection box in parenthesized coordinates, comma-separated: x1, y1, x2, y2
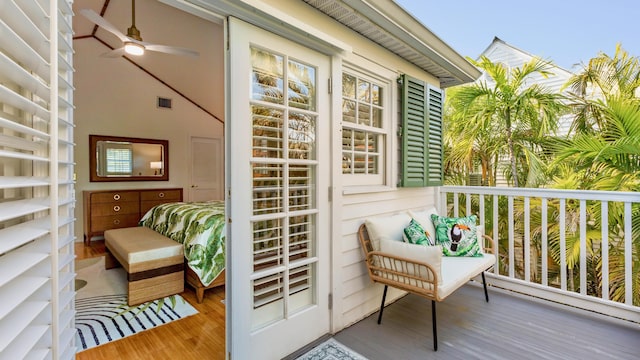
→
(445, 56, 564, 187)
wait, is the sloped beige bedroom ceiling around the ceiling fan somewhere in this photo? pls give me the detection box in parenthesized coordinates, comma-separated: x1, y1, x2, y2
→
(73, 0, 224, 119)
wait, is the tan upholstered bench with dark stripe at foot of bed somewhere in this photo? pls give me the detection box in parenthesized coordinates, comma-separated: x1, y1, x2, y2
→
(104, 226, 184, 306)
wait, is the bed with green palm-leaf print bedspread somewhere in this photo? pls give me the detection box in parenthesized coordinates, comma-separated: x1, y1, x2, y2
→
(140, 201, 226, 303)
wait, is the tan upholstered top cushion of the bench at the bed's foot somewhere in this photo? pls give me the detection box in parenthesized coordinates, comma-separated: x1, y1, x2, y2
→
(104, 226, 184, 265)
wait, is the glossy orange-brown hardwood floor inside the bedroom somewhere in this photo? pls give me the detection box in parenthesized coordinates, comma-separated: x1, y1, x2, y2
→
(75, 240, 225, 360)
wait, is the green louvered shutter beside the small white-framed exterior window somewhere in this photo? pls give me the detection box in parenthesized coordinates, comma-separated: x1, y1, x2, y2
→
(400, 75, 444, 187)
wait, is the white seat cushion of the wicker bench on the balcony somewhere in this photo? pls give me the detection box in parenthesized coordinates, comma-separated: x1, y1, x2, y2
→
(438, 254, 496, 300)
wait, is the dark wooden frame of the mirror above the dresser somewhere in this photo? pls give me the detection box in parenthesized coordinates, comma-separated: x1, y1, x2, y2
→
(89, 135, 169, 182)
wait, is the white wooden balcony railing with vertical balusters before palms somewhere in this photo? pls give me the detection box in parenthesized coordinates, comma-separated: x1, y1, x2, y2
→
(439, 186, 640, 322)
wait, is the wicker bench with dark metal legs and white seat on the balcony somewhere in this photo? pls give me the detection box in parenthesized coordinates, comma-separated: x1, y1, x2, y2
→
(358, 217, 495, 351)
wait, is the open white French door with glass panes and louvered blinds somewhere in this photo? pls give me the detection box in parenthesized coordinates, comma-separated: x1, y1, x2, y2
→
(227, 18, 330, 359)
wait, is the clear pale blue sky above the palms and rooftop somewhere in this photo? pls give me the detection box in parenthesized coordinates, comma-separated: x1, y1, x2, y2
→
(395, 0, 640, 71)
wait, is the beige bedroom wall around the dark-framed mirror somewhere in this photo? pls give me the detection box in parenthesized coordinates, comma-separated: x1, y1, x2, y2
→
(74, 21, 224, 241)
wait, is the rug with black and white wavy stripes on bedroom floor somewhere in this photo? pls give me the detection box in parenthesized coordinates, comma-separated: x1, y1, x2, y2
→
(76, 260, 198, 351)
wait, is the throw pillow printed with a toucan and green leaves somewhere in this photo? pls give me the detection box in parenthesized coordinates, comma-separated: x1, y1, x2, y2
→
(431, 214, 482, 256)
